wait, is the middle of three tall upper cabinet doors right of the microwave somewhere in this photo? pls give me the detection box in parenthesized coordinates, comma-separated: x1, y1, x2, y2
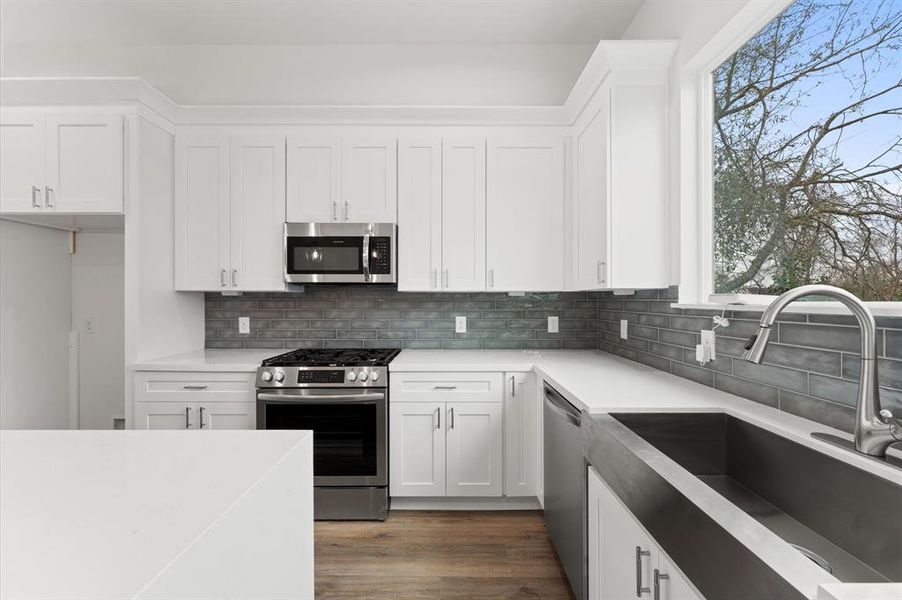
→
(442, 138, 486, 291)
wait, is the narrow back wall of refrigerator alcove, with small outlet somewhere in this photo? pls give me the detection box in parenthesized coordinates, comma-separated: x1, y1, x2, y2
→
(72, 232, 125, 429)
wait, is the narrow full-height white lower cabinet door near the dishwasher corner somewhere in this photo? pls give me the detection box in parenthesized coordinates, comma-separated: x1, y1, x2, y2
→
(504, 373, 539, 496)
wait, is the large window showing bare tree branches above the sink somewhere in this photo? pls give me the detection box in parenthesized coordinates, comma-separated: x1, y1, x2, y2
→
(711, 0, 902, 301)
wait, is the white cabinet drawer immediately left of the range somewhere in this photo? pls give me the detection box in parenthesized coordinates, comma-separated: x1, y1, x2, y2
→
(135, 372, 256, 402)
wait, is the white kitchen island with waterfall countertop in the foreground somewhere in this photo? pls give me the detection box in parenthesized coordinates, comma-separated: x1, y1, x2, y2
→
(0, 431, 313, 600)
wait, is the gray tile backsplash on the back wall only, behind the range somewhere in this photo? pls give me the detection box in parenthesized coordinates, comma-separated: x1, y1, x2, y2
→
(206, 285, 598, 350)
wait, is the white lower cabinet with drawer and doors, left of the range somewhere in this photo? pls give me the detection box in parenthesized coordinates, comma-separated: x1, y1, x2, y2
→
(135, 372, 257, 429)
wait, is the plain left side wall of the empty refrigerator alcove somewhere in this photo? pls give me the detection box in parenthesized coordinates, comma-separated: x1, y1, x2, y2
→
(0, 220, 72, 429)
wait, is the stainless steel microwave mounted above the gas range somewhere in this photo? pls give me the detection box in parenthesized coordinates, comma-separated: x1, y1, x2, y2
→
(283, 223, 398, 283)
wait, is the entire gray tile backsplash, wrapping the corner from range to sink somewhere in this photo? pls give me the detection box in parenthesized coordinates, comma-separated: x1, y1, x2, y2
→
(206, 285, 902, 431)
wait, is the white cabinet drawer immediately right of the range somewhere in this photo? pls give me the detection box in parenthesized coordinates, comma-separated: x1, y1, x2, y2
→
(390, 373, 504, 402)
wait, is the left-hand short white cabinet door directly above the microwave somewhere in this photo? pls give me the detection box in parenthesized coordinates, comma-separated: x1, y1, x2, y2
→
(286, 135, 347, 223)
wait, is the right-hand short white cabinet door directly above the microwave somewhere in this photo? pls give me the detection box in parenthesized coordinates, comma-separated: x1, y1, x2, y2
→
(341, 138, 398, 223)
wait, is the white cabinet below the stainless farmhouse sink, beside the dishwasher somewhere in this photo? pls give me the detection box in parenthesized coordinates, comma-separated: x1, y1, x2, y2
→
(588, 467, 702, 600)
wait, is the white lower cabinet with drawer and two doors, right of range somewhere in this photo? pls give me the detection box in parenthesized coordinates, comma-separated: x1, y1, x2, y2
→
(389, 373, 504, 498)
